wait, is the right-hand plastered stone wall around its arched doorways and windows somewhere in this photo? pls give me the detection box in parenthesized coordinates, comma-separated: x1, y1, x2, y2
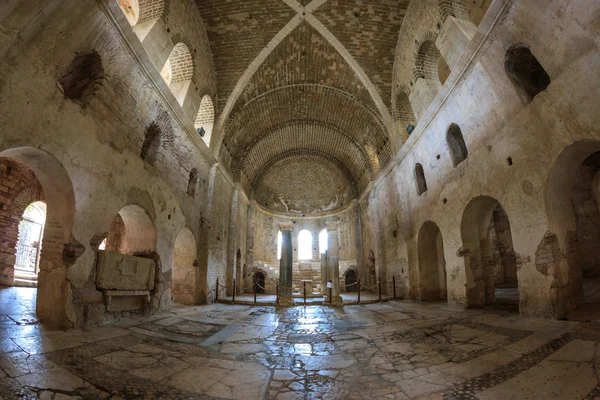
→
(361, 0, 600, 317)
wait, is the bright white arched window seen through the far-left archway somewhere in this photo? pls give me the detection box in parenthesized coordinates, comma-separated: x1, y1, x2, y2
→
(15, 201, 46, 274)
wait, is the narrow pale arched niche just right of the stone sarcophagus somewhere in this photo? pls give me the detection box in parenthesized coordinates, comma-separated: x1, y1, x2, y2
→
(171, 228, 197, 304)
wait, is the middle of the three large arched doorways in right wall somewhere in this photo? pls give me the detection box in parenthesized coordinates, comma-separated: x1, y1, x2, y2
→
(461, 196, 519, 310)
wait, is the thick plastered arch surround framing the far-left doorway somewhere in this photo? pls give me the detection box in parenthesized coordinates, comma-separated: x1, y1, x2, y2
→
(0, 147, 77, 328)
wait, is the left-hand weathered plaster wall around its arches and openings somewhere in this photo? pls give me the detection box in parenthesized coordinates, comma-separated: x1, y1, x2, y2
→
(0, 0, 236, 326)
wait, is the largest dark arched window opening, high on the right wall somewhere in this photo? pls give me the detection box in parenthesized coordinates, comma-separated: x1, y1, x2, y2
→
(504, 45, 551, 102)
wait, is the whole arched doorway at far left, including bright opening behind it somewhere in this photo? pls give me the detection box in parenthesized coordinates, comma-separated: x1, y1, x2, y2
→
(0, 147, 80, 328)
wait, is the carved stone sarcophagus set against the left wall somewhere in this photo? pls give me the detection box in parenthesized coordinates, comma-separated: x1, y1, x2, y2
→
(96, 251, 155, 311)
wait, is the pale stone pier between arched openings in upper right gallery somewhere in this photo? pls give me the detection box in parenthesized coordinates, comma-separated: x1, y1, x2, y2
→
(435, 16, 477, 70)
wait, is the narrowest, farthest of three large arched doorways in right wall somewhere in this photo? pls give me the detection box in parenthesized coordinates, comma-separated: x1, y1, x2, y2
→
(418, 221, 448, 301)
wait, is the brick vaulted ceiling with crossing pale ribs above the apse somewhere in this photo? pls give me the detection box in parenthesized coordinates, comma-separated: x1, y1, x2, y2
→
(196, 0, 410, 215)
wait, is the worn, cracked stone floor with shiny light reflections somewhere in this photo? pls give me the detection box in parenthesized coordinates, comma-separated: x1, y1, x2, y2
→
(0, 288, 600, 400)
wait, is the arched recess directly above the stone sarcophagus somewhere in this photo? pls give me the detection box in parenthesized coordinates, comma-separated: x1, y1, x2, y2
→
(106, 204, 156, 255)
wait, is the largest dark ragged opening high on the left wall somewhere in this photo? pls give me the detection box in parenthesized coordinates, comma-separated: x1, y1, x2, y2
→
(58, 51, 104, 107)
